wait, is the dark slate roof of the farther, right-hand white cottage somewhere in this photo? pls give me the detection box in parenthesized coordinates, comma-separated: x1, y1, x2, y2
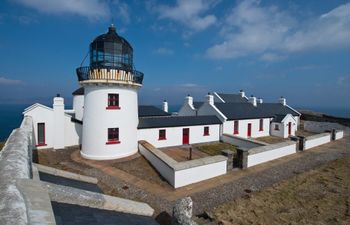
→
(215, 103, 299, 120)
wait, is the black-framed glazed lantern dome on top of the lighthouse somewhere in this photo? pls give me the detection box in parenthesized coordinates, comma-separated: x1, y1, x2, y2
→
(90, 24, 133, 71)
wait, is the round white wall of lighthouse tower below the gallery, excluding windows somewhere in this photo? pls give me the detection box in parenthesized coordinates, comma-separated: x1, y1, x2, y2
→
(81, 86, 138, 160)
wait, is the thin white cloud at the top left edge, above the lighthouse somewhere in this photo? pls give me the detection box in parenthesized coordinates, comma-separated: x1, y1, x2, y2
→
(15, 0, 111, 20)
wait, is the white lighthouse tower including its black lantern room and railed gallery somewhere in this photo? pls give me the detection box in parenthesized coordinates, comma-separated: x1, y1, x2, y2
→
(77, 25, 143, 160)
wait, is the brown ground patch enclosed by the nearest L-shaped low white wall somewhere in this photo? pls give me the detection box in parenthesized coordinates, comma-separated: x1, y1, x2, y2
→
(161, 147, 209, 162)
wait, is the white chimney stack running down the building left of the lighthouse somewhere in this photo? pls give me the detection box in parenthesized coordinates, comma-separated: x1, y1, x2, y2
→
(52, 94, 65, 149)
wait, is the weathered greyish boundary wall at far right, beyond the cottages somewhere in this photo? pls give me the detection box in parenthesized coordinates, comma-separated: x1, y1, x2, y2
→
(304, 120, 350, 136)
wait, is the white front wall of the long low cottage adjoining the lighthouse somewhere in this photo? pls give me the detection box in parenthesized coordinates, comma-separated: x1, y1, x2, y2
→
(137, 124, 220, 148)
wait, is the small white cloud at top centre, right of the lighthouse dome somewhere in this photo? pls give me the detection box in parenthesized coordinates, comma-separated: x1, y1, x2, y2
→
(156, 0, 217, 31)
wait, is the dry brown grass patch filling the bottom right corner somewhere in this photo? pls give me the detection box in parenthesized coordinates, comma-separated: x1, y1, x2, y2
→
(212, 156, 350, 225)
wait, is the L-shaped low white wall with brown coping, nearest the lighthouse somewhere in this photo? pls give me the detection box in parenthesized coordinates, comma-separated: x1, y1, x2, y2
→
(139, 141, 227, 188)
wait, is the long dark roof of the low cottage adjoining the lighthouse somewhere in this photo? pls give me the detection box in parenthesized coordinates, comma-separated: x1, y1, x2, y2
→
(138, 116, 221, 129)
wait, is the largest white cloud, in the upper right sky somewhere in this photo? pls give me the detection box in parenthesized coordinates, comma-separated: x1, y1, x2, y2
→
(206, 0, 350, 61)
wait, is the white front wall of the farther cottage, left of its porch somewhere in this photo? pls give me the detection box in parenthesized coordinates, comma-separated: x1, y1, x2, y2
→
(223, 118, 270, 138)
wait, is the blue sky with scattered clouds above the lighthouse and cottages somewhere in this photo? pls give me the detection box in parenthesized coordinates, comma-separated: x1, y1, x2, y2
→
(0, 0, 350, 108)
